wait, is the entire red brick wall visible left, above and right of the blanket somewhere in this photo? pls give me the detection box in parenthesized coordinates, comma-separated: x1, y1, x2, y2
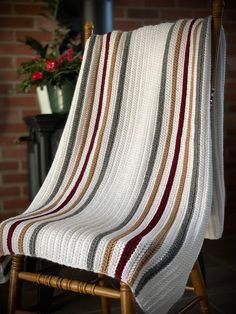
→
(0, 0, 236, 233)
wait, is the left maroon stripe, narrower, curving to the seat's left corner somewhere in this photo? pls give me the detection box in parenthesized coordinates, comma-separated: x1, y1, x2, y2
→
(7, 33, 111, 254)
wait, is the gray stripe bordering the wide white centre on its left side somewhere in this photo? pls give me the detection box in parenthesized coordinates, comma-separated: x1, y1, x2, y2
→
(30, 32, 132, 254)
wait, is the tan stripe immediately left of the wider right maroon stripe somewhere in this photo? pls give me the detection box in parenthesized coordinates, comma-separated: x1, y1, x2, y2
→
(101, 20, 187, 274)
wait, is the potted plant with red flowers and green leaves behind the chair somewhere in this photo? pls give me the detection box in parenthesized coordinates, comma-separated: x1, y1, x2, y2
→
(18, 0, 82, 113)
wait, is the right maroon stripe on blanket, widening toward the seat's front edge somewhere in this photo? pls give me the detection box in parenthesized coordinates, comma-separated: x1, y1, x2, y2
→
(115, 20, 195, 279)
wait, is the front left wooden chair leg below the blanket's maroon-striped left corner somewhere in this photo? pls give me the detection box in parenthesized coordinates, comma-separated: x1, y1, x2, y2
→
(8, 255, 24, 314)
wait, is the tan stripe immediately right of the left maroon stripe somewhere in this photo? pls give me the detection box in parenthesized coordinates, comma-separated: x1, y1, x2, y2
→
(18, 32, 122, 254)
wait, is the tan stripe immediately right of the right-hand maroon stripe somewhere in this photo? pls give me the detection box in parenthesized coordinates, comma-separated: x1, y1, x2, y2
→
(129, 22, 202, 285)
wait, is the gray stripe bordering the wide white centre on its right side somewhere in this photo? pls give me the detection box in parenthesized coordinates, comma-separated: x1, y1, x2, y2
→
(87, 26, 173, 270)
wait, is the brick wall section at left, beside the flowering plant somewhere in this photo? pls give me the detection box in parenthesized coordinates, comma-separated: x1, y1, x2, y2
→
(0, 0, 51, 220)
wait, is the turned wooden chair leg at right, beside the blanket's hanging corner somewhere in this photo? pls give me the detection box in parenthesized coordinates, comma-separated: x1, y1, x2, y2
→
(191, 261, 211, 314)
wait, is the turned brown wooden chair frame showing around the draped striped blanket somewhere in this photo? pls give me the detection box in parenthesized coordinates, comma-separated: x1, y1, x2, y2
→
(8, 0, 224, 314)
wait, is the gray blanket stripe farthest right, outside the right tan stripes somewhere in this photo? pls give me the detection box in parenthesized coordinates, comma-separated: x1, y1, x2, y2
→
(135, 20, 207, 296)
